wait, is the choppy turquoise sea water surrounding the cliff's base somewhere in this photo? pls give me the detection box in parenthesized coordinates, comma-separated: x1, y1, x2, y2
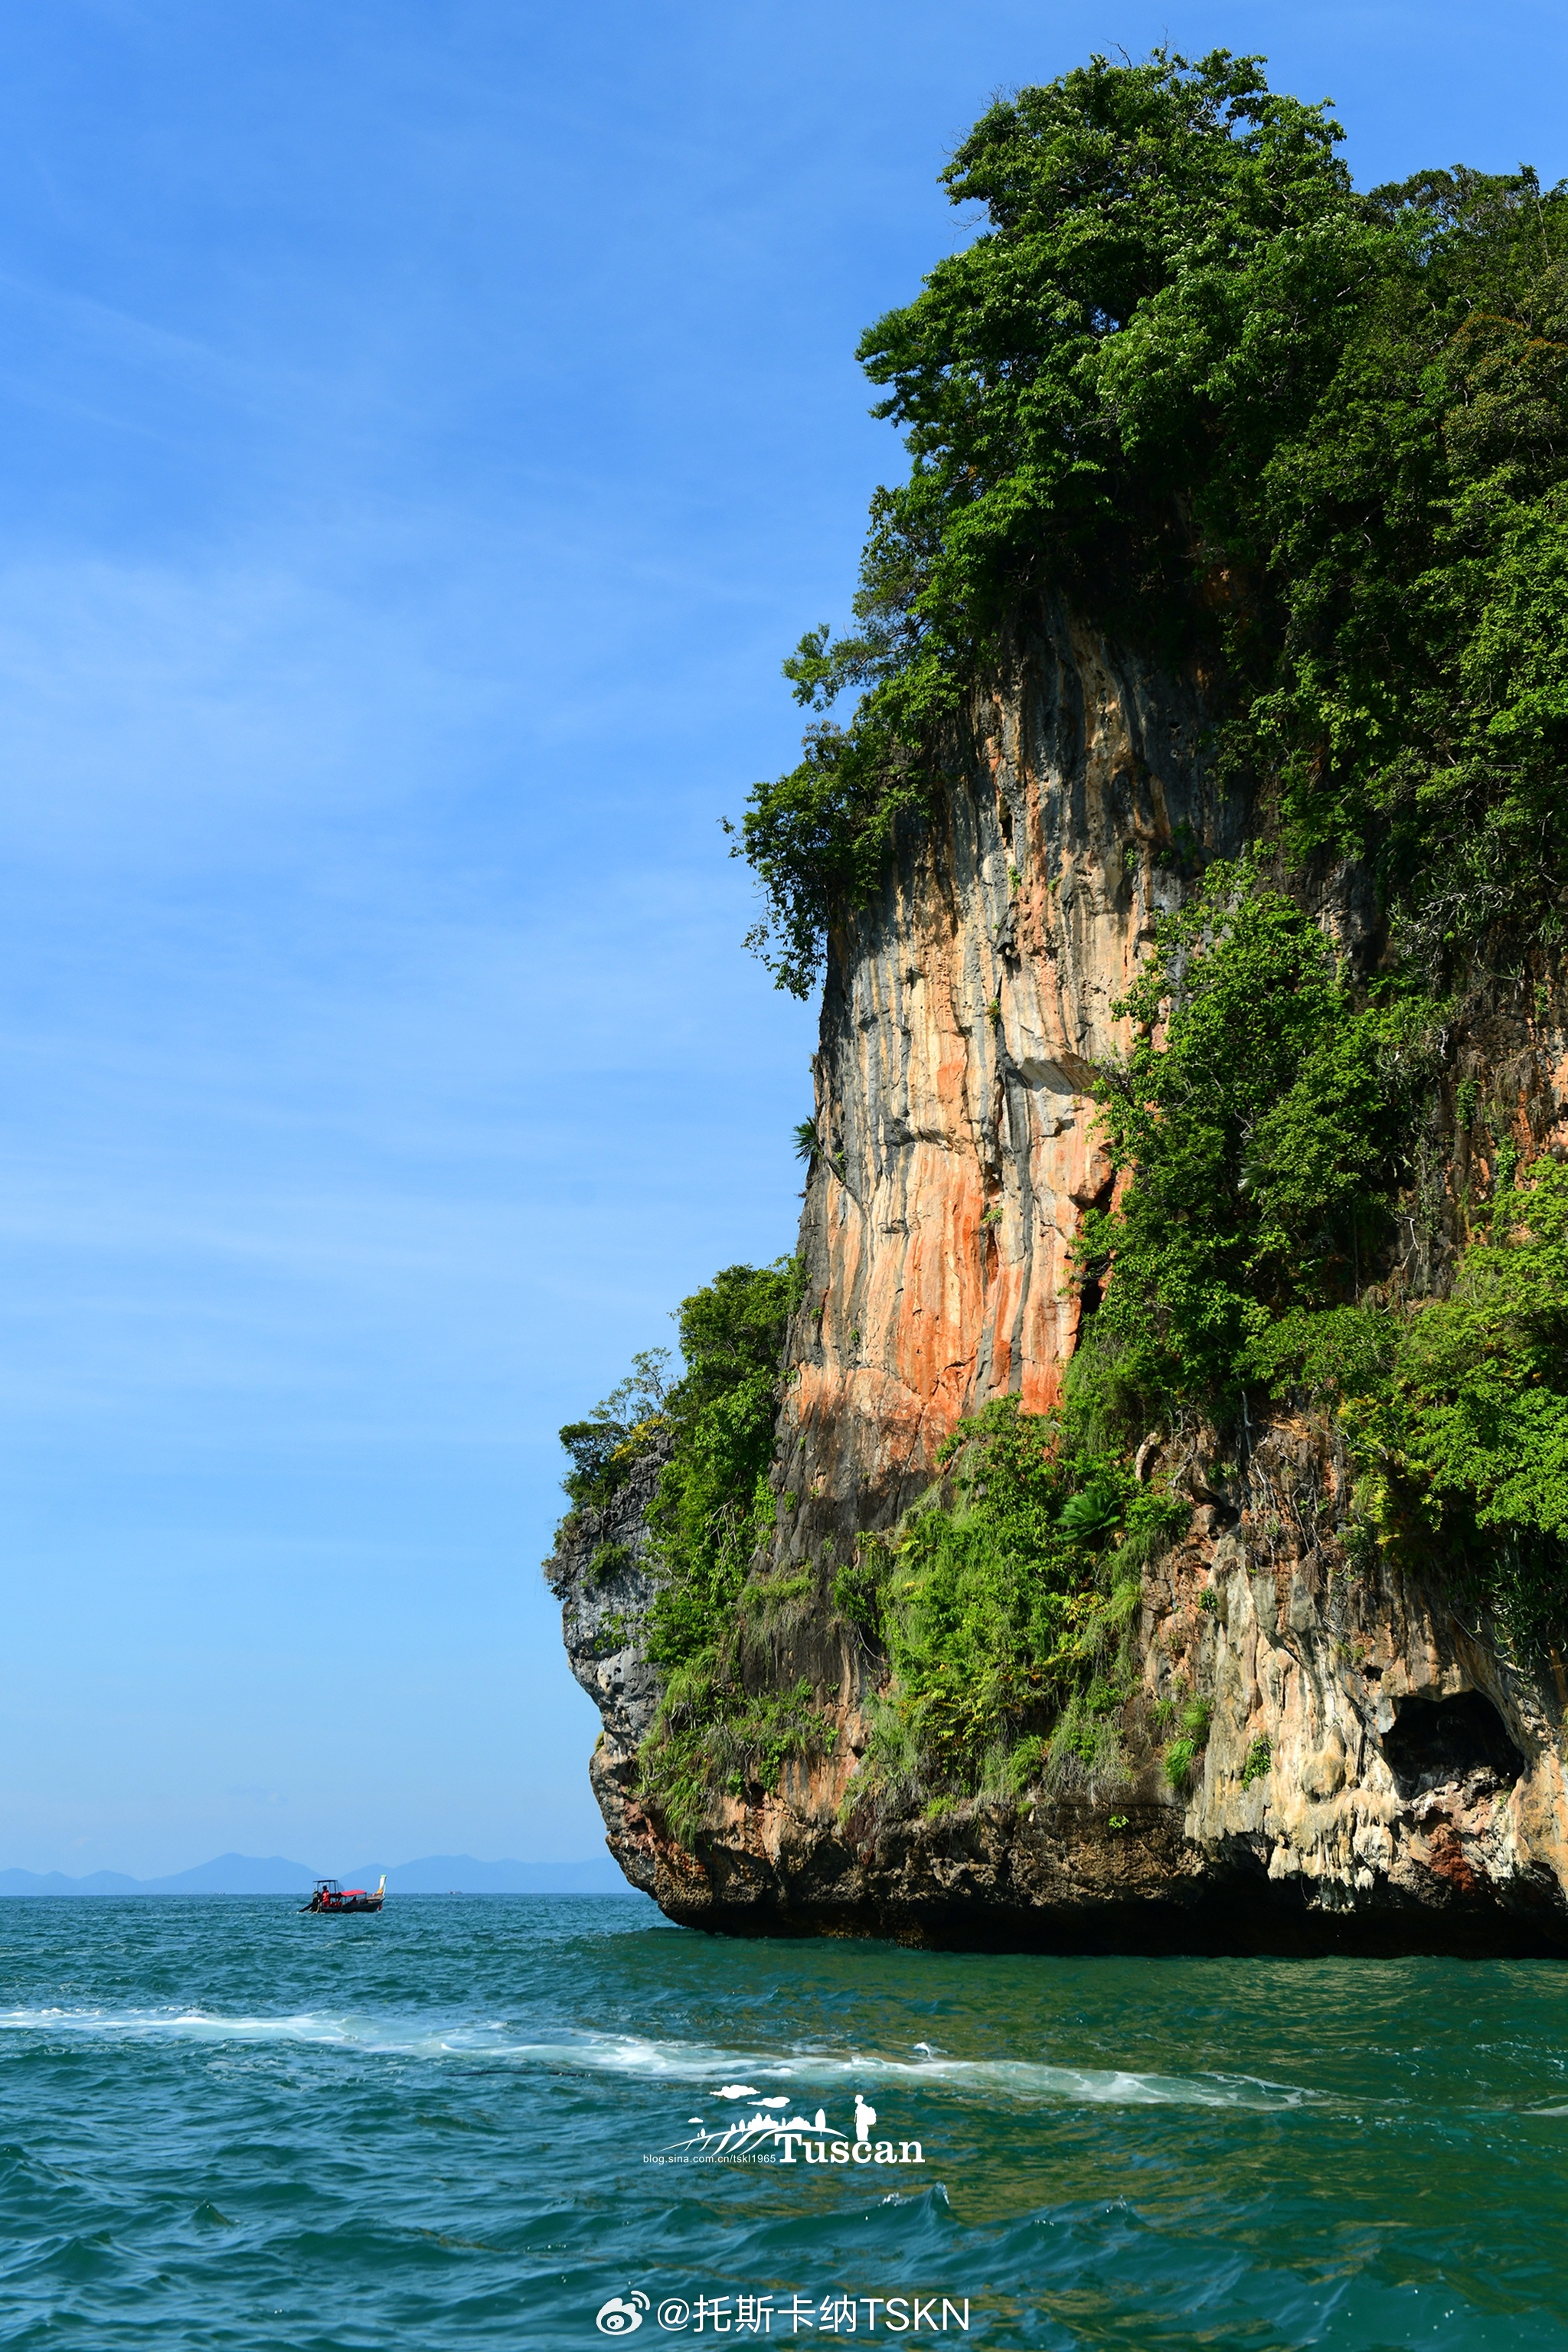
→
(0, 1896, 1568, 2352)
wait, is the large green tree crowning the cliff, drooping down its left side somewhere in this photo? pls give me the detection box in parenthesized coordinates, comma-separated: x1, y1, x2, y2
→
(740, 50, 1387, 995)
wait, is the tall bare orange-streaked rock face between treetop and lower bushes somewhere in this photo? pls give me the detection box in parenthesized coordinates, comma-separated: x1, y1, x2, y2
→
(780, 614, 1248, 1553)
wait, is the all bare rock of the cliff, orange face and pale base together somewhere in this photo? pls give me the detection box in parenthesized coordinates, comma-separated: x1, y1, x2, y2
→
(553, 597, 1568, 1955)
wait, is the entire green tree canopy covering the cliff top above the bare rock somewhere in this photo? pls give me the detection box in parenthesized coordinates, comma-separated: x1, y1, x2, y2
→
(740, 50, 1568, 995)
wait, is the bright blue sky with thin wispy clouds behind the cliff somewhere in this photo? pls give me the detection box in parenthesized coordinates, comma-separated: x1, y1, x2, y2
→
(0, 0, 1568, 1872)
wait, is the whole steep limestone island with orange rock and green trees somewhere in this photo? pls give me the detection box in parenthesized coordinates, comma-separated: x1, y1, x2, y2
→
(547, 52, 1568, 1955)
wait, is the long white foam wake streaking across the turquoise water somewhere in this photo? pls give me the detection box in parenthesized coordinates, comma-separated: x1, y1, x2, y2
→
(0, 2008, 1321, 2110)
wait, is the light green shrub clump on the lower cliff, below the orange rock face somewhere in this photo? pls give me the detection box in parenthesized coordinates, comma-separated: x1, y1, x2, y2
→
(861, 1397, 1190, 1795)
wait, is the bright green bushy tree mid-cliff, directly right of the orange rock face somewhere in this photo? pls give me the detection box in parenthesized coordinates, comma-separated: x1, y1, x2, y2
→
(1079, 865, 1432, 1426)
